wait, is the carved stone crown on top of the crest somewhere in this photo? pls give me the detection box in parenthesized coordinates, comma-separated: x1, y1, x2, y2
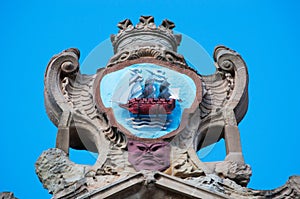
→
(111, 16, 181, 54)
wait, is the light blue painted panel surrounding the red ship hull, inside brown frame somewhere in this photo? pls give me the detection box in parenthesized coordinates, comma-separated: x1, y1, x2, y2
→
(100, 63, 196, 138)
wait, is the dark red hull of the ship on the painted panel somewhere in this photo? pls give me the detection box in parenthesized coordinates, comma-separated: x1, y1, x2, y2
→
(120, 98, 175, 115)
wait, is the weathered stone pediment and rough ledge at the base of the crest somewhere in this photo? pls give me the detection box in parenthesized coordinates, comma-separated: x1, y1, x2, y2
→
(35, 149, 300, 199)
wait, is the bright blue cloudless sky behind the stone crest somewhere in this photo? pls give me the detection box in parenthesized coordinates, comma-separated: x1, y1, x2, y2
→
(0, 0, 300, 199)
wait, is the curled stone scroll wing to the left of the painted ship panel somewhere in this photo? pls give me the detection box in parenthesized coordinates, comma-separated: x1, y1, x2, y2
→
(44, 48, 125, 156)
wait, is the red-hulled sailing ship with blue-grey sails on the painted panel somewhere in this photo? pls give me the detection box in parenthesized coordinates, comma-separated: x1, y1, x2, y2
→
(119, 71, 176, 115)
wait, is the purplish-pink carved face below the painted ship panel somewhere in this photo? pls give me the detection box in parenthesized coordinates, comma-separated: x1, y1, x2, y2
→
(128, 141, 171, 171)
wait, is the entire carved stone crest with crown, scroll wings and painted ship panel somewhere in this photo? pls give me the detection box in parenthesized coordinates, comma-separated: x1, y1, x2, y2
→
(36, 16, 299, 198)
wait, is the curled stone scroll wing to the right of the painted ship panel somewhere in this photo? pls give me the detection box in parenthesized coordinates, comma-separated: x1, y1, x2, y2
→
(196, 46, 248, 148)
